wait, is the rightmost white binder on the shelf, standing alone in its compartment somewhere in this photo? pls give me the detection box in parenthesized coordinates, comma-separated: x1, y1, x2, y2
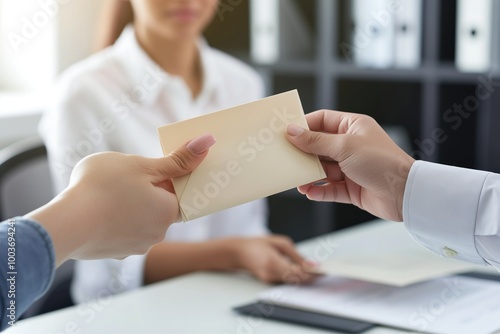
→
(455, 0, 493, 72)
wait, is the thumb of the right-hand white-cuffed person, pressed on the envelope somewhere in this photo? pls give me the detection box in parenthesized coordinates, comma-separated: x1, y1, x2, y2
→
(287, 124, 342, 161)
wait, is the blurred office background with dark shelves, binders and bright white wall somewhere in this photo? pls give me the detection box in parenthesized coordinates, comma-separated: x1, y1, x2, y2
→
(0, 0, 500, 241)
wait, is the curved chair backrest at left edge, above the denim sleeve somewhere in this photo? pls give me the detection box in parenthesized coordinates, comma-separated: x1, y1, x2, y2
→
(0, 138, 54, 221)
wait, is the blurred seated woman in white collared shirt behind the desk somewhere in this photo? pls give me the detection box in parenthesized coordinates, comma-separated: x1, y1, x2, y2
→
(40, 0, 311, 302)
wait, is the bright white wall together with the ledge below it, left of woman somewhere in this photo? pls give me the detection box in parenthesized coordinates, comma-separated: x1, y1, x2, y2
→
(0, 0, 104, 148)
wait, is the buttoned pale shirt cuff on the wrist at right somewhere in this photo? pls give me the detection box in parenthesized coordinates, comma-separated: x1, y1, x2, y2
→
(403, 161, 489, 265)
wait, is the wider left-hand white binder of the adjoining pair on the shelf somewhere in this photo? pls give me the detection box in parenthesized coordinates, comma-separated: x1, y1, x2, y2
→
(351, 0, 395, 68)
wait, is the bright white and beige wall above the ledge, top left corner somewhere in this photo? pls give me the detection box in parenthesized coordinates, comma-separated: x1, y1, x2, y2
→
(0, 0, 103, 91)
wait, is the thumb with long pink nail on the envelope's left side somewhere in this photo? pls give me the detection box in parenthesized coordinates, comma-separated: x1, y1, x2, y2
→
(146, 134, 215, 182)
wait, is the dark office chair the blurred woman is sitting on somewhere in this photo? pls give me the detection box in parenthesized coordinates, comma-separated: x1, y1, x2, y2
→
(0, 138, 74, 318)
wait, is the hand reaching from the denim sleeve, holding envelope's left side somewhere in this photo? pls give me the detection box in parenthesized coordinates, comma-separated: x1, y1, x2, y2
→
(26, 135, 215, 264)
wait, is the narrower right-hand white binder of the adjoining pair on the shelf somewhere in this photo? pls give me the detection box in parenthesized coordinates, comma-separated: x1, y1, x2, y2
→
(394, 0, 423, 68)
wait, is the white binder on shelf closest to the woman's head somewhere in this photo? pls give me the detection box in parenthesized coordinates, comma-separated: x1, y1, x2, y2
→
(250, 0, 314, 64)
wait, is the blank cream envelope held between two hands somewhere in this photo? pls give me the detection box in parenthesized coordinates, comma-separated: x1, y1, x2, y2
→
(158, 90, 326, 221)
